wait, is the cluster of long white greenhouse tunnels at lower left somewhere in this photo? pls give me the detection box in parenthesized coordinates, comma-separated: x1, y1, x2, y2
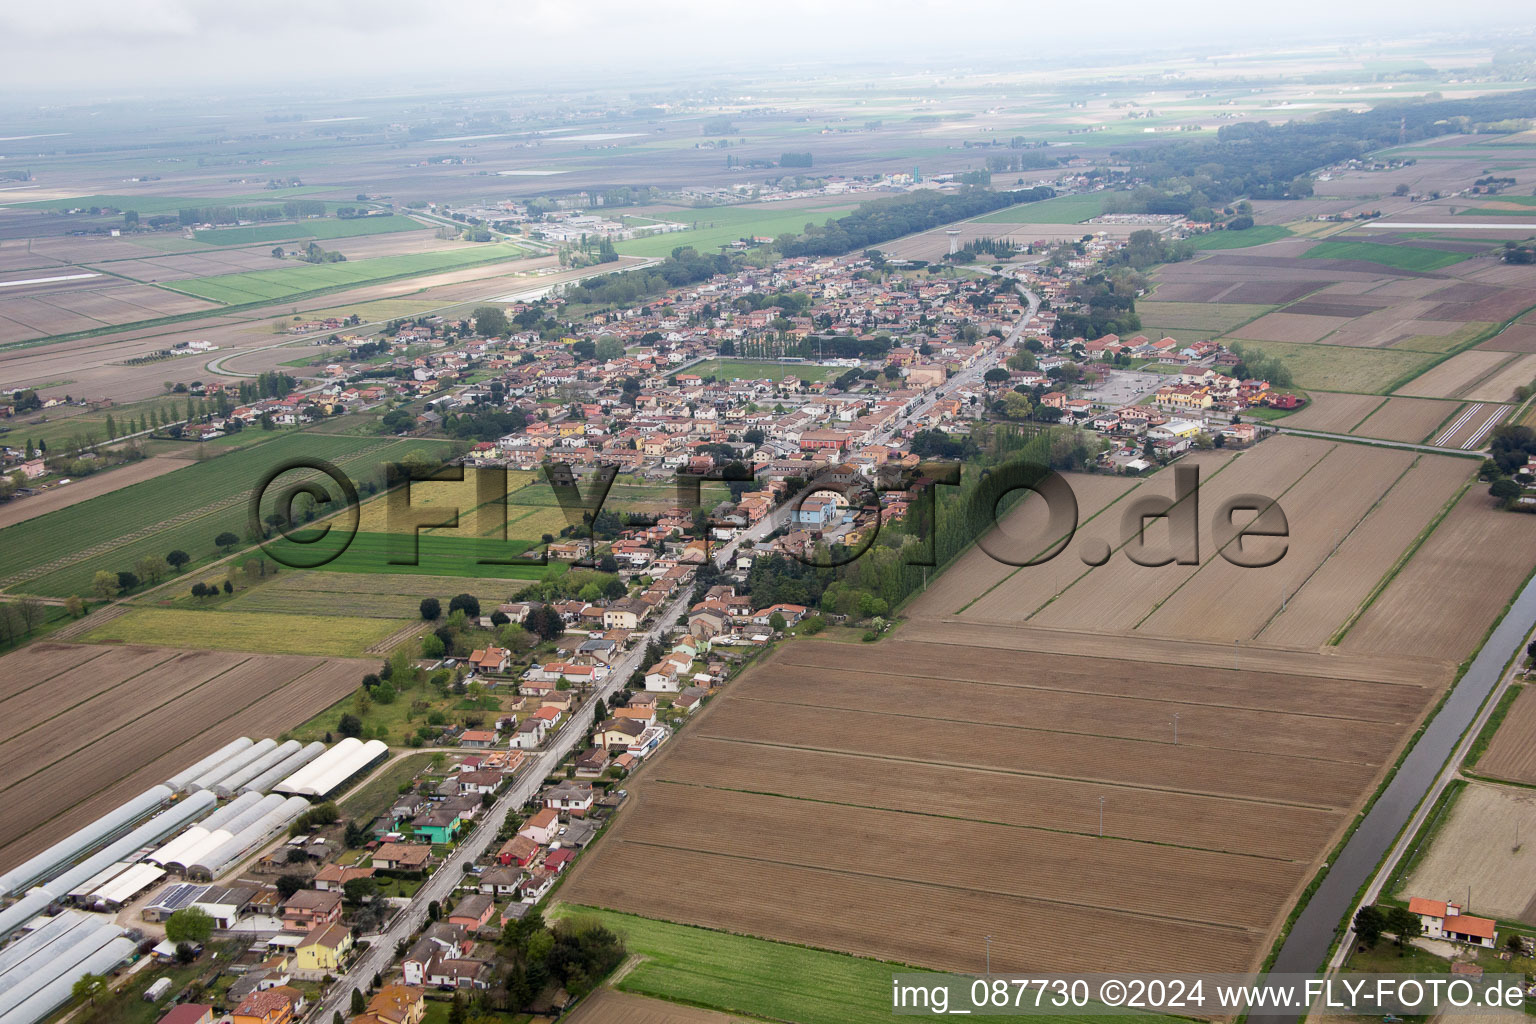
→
(0, 737, 389, 1024)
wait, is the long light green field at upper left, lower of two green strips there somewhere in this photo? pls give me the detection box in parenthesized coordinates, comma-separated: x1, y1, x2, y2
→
(161, 244, 528, 306)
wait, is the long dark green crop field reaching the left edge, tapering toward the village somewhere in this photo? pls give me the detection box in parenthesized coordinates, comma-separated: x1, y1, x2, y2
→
(0, 431, 449, 597)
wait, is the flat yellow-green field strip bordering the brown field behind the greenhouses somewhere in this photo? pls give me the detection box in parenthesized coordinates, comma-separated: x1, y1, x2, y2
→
(83, 608, 399, 657)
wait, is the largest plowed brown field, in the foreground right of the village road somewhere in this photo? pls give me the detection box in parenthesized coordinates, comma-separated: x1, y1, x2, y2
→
(562, 626, 1442, 970)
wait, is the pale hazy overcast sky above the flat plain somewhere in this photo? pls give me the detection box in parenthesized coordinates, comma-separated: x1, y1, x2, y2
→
(0, 0, 1530, 101)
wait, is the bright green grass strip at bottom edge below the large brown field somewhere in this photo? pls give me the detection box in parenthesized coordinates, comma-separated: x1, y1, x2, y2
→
(556, 904, 1169, 1024)
